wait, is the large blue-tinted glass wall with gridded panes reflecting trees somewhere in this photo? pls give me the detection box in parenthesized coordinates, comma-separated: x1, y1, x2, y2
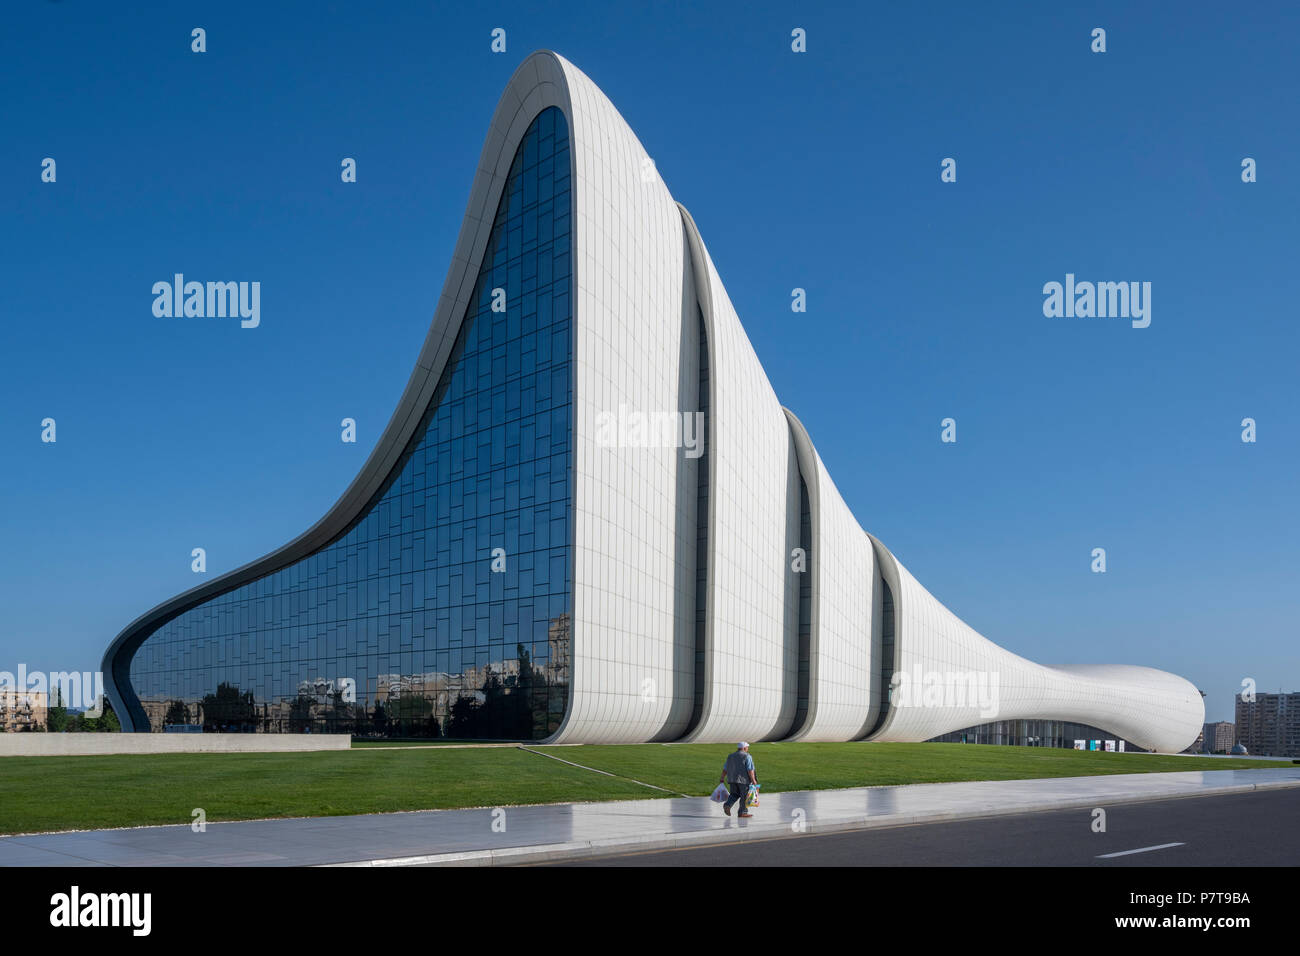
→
(130, 108, 573, 739)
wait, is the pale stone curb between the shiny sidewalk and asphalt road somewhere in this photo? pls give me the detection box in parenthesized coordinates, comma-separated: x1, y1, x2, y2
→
(320, 780, 1300, 866)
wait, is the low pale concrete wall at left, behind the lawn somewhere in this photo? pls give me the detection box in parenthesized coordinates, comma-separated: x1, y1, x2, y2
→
(0, 734, 352, 757)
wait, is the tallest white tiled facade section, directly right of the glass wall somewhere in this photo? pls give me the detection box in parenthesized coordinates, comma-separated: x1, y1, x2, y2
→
(553, 57, 696, 743)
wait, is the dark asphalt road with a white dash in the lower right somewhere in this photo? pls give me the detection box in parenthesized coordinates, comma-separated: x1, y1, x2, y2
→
(530, 788, 1300, 866)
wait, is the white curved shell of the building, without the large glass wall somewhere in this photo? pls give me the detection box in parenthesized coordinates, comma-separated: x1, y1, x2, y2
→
(104, 52, 1204, 752)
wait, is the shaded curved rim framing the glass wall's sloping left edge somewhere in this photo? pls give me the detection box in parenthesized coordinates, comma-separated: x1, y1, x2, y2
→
(109, 49, 577, 731)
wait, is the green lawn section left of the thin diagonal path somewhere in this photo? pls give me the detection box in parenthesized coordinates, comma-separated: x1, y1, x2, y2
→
(0, 747, 653, 834)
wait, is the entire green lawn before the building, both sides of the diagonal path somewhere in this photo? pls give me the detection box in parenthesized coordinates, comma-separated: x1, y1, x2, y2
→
(0, 744, 1292, 834)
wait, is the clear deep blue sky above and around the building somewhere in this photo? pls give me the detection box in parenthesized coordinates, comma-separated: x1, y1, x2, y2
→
(0, 0, 1300, 719)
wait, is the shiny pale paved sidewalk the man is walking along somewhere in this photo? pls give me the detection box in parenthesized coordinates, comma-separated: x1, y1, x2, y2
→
(0, 766, 1300, 866)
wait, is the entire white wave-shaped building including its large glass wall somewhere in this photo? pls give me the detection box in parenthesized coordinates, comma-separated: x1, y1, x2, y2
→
(104, 52, 1204, 752)
